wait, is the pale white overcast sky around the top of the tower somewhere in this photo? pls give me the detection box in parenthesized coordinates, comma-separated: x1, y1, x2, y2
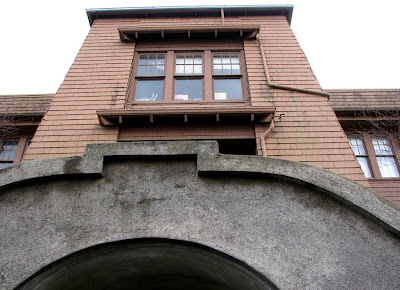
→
(0, 0, 400, 94)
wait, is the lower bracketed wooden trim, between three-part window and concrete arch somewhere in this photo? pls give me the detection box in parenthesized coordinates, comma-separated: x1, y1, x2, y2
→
(96, 107, 275, 126)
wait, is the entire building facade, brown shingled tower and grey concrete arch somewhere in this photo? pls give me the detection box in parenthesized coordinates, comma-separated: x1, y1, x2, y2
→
(0, 5, 400, 289)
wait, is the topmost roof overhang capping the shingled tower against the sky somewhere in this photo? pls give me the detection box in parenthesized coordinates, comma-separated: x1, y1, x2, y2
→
(86, 4, 293, 25)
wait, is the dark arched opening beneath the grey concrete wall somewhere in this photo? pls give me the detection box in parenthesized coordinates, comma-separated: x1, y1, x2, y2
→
(16, 239, 278, 290)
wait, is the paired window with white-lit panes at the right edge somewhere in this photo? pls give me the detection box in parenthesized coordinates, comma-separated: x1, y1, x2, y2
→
(348, 134, 400, 178)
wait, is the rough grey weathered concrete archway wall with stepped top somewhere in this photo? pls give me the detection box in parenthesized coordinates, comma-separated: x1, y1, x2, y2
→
(0, 141, 400, 289)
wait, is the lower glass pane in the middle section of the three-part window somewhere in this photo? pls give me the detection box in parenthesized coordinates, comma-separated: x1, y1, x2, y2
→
(175, 79, 203, 101)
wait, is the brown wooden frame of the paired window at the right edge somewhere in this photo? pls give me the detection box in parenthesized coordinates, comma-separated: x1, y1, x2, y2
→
(348, 133, 400, 180)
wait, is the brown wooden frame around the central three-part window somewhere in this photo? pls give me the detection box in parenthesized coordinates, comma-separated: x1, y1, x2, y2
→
(125, 41, 250, 108)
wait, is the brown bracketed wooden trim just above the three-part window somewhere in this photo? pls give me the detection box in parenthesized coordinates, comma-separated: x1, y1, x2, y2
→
(118, 25, 260, 42)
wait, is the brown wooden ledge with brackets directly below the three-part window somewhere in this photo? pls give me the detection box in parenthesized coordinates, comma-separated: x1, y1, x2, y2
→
(96, 107, 275, 127)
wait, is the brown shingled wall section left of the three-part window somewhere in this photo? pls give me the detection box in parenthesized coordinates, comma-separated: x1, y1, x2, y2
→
(24, 21, 134, 161)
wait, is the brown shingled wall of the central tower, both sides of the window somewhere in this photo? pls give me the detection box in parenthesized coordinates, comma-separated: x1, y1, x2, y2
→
(25, 16, 368, 186)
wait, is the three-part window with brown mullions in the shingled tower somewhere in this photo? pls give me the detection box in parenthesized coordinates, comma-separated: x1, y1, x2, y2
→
(129, 50, 247, 102)
